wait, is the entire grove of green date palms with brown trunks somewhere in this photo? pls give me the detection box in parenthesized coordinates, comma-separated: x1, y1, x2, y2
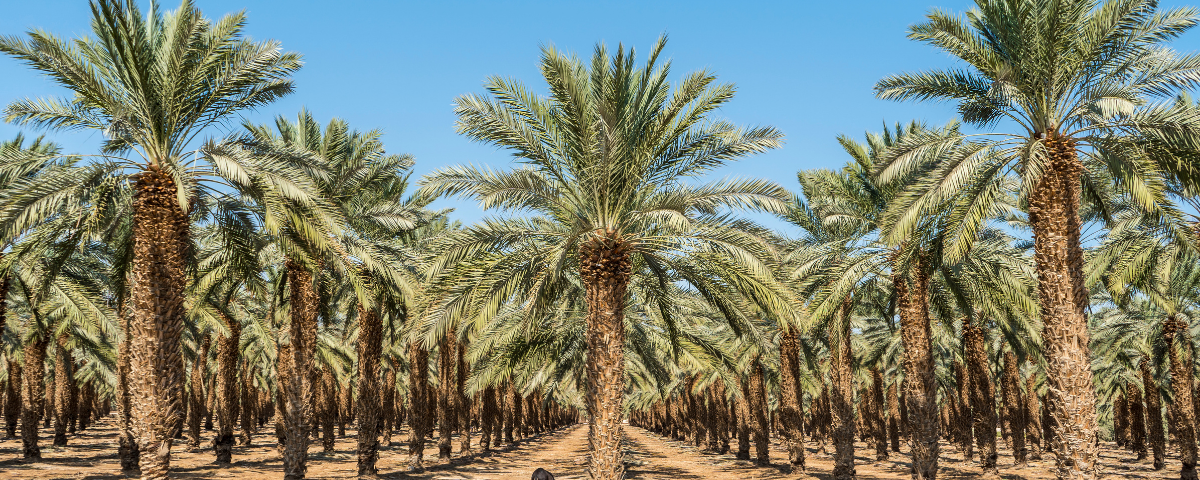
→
(0, 0, 1200, 479)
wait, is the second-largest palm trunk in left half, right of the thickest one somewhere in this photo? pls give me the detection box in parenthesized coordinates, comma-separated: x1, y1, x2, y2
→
(283, 259, 317, 480)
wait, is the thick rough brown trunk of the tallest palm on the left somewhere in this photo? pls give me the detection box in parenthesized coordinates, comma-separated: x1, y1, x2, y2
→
(126, 166, 190, 479)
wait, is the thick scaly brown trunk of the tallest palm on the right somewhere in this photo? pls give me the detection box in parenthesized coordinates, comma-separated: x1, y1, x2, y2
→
(1028, 132, 1099, 479)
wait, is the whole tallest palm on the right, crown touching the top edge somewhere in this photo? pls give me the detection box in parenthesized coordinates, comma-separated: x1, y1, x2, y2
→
(875, 0, 1200, 478)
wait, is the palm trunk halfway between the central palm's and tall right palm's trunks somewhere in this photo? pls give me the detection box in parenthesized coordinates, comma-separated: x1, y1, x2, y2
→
(827, 298, 856, 480)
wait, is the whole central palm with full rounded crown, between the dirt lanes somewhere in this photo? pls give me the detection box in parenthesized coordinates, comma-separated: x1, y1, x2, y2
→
(424, 38, 790, 479)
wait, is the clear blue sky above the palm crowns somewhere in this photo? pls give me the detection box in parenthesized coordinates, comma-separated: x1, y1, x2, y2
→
(7, 0, 1200, 230)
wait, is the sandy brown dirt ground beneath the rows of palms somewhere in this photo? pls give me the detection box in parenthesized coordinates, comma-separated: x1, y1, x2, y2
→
(0, 418, 1178, 480)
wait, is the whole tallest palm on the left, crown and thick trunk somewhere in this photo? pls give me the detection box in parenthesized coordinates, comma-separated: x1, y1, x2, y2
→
(0, 0, 300, 478)
